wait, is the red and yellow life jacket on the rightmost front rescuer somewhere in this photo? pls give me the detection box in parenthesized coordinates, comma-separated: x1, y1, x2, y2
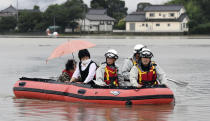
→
(136, 62, 158, 85)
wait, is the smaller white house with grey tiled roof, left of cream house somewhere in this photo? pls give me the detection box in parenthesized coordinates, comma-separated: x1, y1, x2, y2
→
(78, 9, 115, 32)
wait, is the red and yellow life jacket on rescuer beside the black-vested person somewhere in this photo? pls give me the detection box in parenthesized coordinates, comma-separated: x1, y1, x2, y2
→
(104, 65, 119, 86)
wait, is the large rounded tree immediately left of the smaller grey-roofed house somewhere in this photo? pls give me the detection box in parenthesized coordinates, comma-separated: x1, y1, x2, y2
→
(44, 0, 87, 30)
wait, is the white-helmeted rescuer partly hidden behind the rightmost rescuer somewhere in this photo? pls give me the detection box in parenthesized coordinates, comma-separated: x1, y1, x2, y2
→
(122, 44, 146, 86)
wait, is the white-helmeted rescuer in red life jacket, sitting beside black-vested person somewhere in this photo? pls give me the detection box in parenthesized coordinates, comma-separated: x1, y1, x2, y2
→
(95, 49, 123, 87)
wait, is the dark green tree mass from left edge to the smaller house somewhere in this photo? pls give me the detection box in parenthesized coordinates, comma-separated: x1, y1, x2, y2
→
(0, 0, 87, 32)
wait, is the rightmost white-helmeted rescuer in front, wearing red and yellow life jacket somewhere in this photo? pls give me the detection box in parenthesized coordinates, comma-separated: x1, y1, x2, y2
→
(130, 48, 166, 88)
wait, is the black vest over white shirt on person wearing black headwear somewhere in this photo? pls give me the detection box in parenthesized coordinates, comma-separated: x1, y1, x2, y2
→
(79, 60, 96, 83)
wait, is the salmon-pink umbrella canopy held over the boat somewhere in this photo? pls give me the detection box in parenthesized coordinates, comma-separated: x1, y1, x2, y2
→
(47, 40, 96, 61)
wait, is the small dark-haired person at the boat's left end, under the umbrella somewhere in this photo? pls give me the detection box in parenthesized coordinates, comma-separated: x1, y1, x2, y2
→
(57, 59, 76, 82)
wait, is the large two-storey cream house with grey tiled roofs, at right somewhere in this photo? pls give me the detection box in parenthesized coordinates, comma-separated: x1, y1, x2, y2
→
(125, 5, 189, 32)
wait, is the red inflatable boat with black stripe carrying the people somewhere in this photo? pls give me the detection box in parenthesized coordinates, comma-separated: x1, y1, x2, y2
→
(13, 77, 174, 105)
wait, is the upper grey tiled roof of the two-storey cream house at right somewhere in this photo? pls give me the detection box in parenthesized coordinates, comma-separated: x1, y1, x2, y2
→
(144, 5, 184, 12)
